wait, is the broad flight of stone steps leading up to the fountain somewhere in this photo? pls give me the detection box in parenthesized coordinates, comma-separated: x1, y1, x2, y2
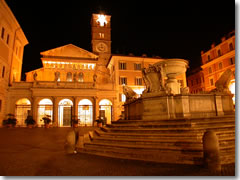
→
(79, 116, 235, 164)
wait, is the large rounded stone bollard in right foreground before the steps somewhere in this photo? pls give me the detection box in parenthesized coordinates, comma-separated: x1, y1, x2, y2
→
(203, 130, 221, 175)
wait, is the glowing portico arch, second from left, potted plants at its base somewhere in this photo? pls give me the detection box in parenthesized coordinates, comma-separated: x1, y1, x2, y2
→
(37, 99, 53, 126)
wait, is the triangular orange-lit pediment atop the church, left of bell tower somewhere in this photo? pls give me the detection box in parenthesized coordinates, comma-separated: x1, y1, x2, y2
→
(40, 44, 98, 59)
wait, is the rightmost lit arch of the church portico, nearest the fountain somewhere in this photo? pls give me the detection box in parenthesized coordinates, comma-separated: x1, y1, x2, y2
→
(99, 99, 112, 124)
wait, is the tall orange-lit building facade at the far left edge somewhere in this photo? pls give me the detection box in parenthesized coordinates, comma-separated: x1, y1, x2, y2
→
(0, 0, 28, 123)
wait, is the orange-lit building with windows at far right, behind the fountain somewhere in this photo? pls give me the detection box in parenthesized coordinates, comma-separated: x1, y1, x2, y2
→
(187, 31, 235, 104)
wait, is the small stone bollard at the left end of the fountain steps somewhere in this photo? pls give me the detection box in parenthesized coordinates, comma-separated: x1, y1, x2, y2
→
(64, 129, 78, 154)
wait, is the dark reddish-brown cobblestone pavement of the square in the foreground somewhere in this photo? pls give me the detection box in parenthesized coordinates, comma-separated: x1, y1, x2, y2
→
(0, 127, 235, 176)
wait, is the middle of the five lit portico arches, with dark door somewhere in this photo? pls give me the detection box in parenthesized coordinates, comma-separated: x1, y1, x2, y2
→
(58, 99, 73, 127)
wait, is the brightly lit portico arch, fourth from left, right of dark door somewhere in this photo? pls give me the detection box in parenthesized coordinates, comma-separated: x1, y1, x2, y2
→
(78, 99, 93, 126)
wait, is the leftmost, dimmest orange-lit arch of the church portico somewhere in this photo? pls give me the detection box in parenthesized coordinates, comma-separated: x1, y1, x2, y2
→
(15, 98, 31, 126)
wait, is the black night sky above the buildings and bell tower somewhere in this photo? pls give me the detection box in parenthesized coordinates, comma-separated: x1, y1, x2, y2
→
(6, 0, 235, 78)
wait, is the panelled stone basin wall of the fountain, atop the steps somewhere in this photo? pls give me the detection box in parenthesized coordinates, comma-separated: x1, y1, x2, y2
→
(124, 94, 235, 120)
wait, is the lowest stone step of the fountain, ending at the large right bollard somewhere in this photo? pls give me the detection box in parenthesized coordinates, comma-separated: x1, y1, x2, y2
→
(80, 144, 203, 164)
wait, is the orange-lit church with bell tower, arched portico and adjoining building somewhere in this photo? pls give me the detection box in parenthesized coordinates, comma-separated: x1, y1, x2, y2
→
(3, 11, 186, 127)
